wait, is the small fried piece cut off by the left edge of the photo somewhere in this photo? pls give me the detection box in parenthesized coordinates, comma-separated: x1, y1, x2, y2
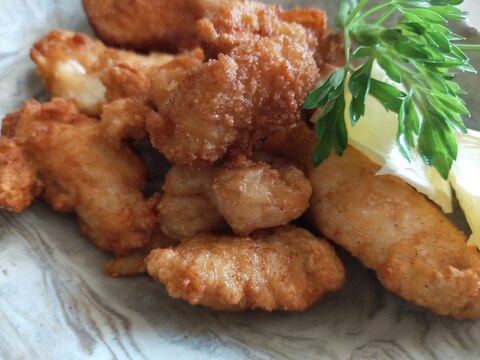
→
(0, 137, 38, 212)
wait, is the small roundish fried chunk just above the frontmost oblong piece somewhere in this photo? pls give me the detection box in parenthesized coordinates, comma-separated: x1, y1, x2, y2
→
(212, 154, 312, 235)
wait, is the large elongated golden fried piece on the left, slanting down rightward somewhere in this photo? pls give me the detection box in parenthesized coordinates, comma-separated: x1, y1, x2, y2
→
(2, 98, 155, 254)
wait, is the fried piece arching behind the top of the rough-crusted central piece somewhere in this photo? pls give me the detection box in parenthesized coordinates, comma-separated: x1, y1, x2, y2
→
(197, 1, 344, 76)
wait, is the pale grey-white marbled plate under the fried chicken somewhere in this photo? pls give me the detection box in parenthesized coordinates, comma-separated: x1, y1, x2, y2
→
(0, 0, 480, 360)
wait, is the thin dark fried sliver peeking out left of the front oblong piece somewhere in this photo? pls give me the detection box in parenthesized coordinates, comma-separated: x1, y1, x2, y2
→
(104, 231, 178, 276)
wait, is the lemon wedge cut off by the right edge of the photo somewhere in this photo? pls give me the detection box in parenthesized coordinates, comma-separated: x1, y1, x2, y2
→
(449, 130, 480, 249)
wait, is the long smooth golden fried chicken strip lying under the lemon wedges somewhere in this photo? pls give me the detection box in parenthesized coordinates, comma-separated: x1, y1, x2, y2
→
(268, 123, 480, 319)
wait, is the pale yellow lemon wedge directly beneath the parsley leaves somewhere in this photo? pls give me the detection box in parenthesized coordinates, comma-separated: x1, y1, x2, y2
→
(345, 64, 454, 213)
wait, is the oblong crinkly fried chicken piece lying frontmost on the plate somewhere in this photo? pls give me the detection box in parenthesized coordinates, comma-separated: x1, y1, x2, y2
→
(147, 226, 345, 311)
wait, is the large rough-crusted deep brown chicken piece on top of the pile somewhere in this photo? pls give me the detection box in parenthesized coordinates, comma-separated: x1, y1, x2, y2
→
(147, 36, 318, 167)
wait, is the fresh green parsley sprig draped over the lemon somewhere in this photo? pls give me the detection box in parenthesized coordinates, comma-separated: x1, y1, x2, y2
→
(303, 0, 480, 179)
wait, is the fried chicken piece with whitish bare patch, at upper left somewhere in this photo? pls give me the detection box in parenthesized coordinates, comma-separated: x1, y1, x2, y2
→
(30, 30, 203, 115)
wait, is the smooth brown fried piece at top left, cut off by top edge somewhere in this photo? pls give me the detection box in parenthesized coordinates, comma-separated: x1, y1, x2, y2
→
(83, 0, 230, 51)
